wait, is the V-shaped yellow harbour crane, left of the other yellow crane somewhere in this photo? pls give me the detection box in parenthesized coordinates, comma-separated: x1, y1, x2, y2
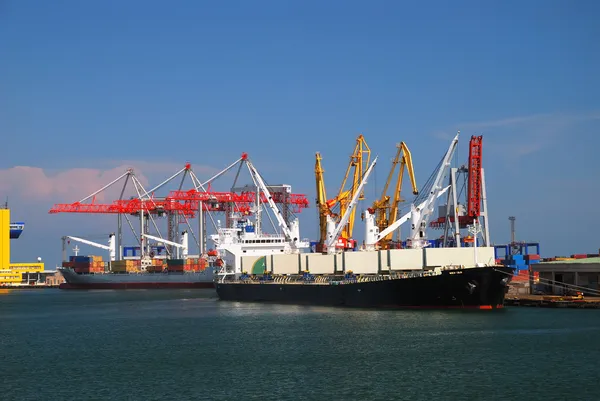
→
(315, 135, 371, 252)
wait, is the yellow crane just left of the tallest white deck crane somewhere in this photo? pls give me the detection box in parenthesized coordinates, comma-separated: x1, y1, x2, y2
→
(372, 142, 419, 249)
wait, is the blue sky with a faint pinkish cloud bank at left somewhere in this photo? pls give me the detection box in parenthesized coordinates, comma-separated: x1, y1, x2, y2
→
(0, 0, 600, 268)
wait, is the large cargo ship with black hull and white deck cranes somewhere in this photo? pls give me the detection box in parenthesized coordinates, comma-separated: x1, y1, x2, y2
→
(215, 135, 514, 309)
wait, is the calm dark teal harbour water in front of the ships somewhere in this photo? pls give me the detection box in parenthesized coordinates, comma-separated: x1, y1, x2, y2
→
(0, 289, 600, 401)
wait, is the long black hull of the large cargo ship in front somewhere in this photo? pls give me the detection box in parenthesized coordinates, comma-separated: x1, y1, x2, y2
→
(216, 266, 513, 309)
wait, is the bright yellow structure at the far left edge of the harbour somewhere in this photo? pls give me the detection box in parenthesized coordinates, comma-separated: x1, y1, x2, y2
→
(0, 208, 44, 286)
